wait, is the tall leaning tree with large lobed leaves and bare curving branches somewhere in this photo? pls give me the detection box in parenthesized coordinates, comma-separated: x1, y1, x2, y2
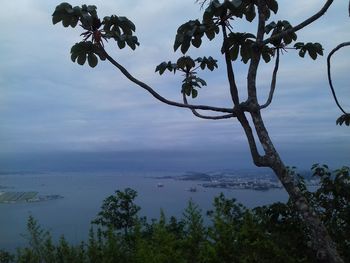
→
(52, 0, 348, 262)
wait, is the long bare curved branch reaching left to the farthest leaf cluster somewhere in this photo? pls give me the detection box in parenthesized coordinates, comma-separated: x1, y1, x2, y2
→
(100, 46, 233, 113)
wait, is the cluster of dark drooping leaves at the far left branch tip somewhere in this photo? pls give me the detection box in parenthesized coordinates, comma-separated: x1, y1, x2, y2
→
(52, 3, 140, 68)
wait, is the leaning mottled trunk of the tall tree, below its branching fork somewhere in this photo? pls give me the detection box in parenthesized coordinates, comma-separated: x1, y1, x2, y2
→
(251, 112, 344, 263)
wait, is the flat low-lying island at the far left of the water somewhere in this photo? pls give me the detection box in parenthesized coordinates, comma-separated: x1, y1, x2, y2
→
(0, 192, 63, 204)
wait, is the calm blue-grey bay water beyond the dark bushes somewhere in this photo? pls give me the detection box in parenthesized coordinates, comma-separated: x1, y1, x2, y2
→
(0, 173, 287, 250)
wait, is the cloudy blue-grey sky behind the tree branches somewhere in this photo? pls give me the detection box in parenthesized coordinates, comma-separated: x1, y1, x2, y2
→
(0, 0, 350, 171)
